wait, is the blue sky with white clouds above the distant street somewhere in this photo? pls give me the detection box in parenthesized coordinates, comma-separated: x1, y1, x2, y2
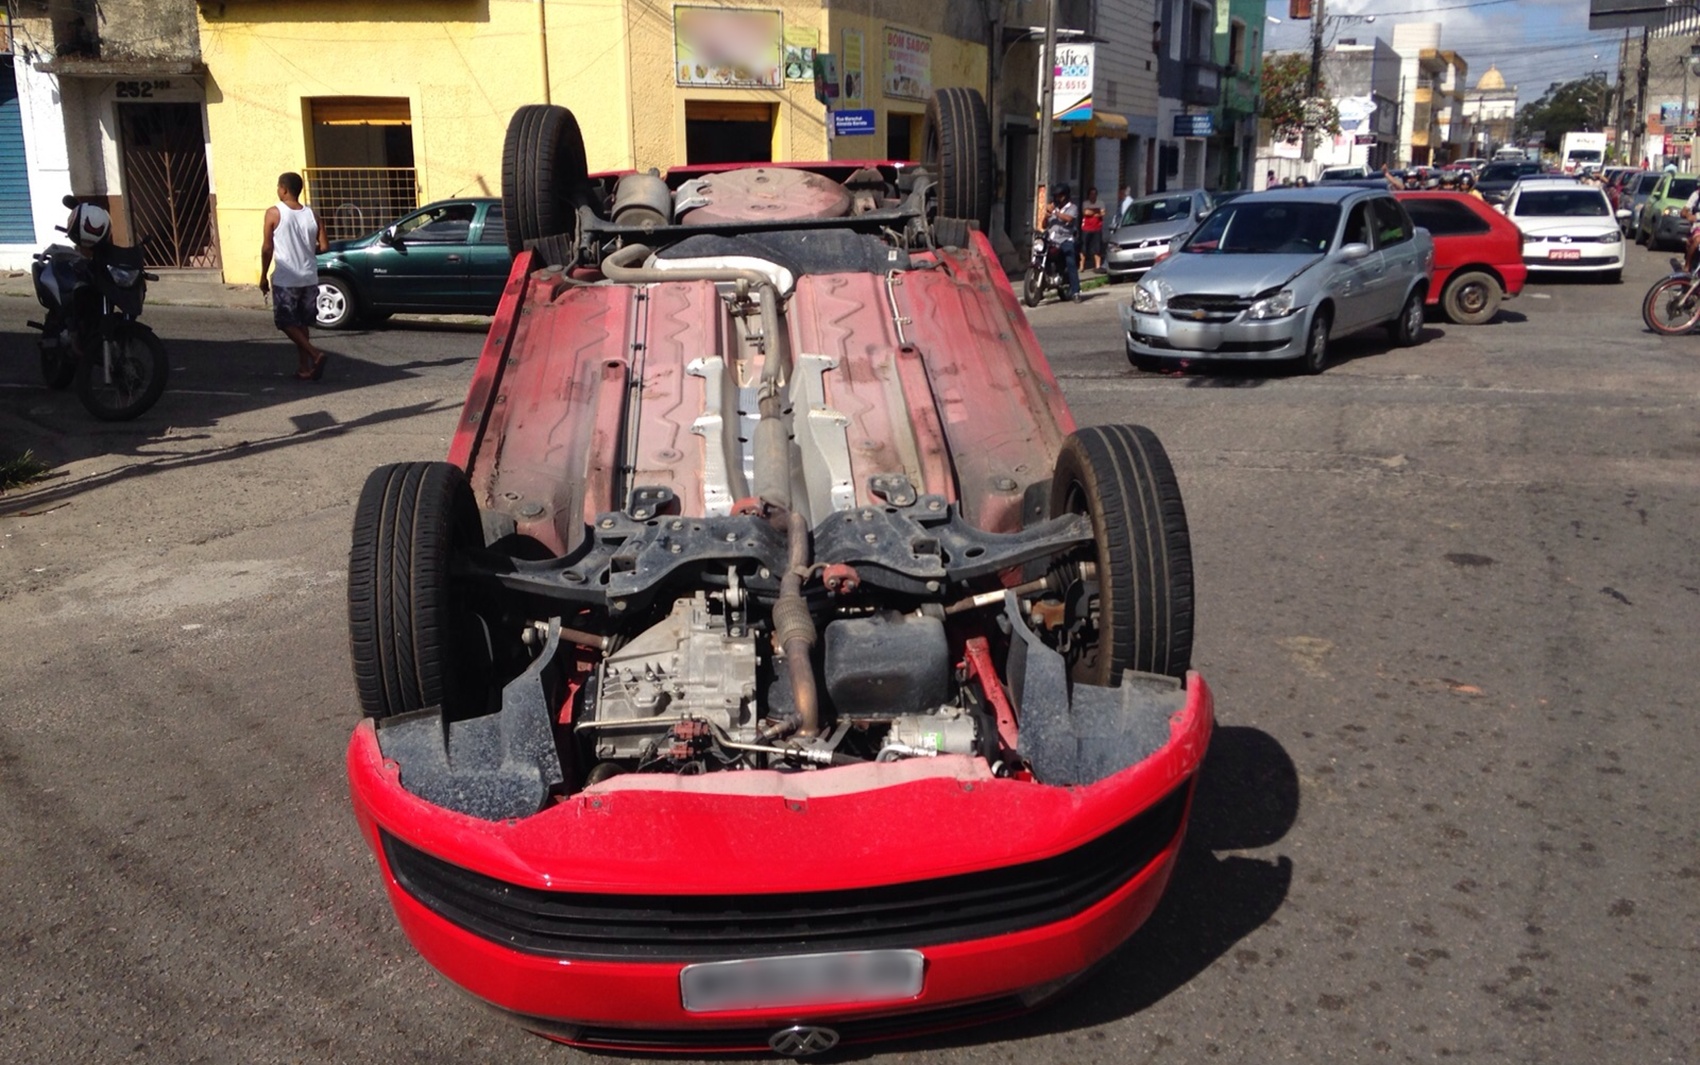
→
(1265, 0, 1639, 104)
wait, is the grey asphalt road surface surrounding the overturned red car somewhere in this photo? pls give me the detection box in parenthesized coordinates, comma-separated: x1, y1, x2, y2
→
(0, 239, 1700, 1065)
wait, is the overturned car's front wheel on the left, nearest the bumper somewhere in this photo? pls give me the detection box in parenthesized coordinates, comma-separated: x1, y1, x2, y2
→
(349, 463, 488, 718)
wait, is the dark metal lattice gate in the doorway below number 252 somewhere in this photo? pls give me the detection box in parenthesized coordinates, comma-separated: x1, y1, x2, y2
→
(117, 104, 219, 269)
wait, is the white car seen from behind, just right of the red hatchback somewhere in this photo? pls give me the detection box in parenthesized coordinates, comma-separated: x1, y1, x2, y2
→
(1505, 177, 1624, 284)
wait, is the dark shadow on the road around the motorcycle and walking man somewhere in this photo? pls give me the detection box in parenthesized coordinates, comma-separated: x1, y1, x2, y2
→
(0, 332, 476, 515)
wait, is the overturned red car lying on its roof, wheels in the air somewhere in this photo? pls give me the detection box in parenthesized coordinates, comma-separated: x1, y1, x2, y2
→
(347, 90, 1212, 1056)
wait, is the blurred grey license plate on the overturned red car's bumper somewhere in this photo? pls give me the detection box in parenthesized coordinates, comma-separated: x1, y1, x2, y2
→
(678, 951, 925, 1012)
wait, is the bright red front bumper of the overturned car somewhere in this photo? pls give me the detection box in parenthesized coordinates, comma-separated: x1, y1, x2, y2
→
(349, 674, 1212, 1051)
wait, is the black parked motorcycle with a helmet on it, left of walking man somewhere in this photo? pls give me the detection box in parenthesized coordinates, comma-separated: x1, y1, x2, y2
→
(29, 196, 170, 422)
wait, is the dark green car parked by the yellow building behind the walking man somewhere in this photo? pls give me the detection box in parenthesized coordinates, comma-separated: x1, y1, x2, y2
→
(316, 199, 513, 328)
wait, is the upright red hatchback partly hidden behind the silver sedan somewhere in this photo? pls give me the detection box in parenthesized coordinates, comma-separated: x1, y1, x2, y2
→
(1394, 192, 1528, 325)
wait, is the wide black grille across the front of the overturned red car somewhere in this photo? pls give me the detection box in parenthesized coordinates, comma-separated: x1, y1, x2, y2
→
(383, 784, 1188, 960)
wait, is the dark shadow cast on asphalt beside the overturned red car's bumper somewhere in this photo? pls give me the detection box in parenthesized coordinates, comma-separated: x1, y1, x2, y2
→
(802, 726, 1299, 1062)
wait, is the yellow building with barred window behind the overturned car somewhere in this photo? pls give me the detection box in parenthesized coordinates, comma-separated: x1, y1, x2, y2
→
(199, 0, 986, 282)
